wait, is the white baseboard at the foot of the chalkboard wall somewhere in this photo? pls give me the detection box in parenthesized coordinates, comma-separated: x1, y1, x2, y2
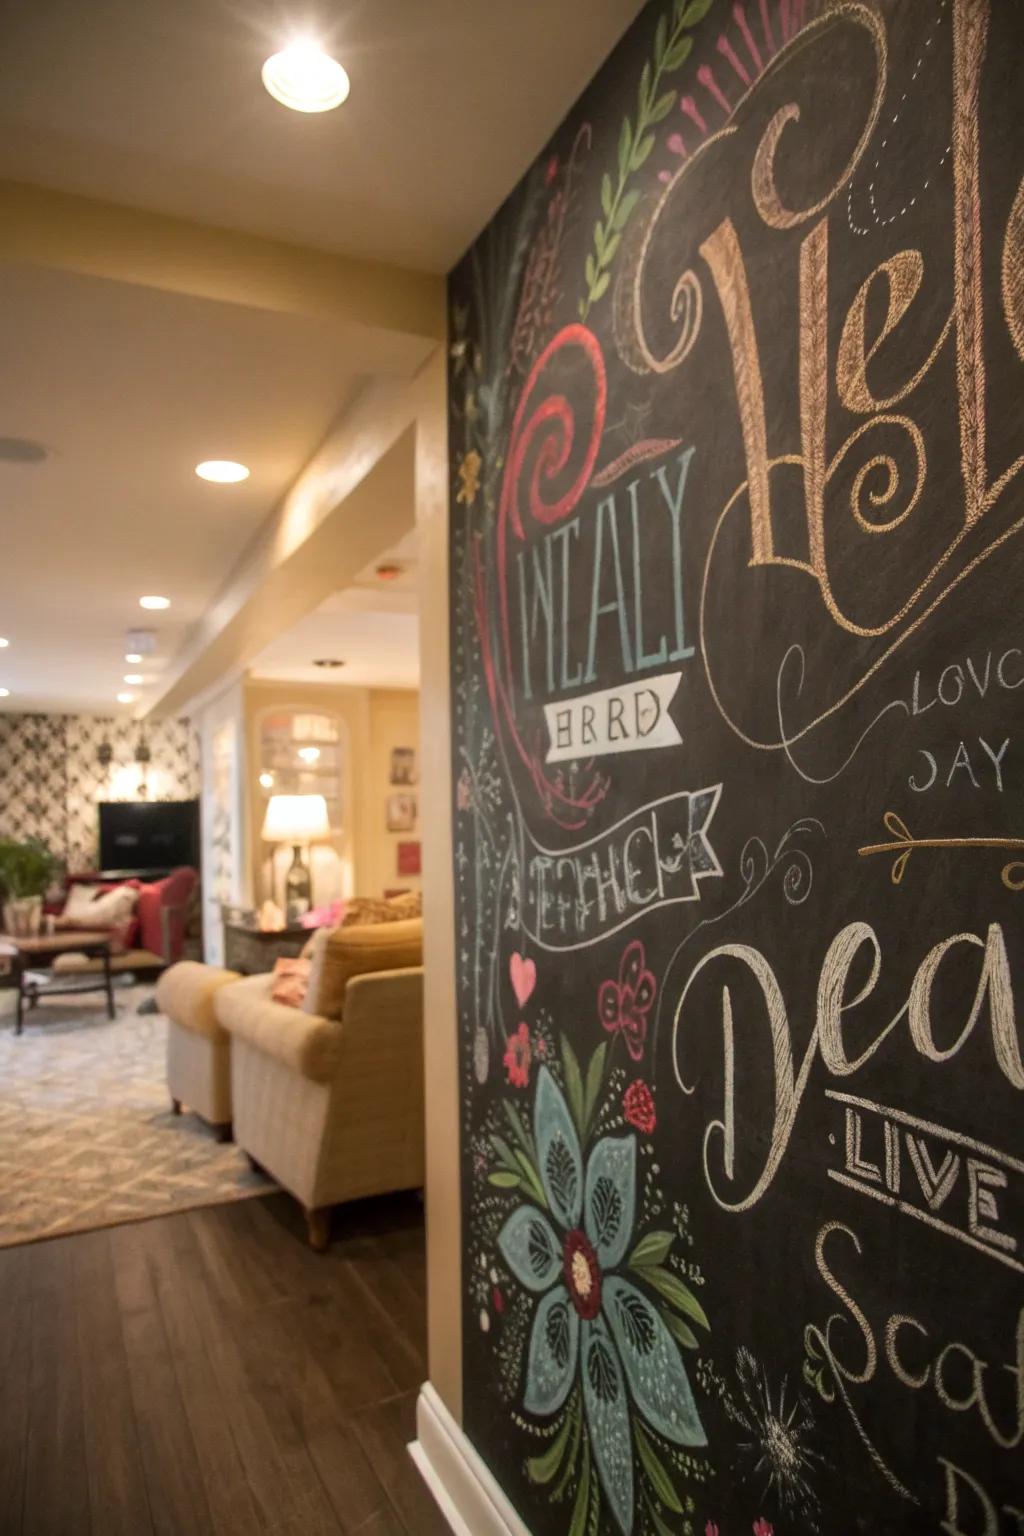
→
(408, 1381, 530, 1536)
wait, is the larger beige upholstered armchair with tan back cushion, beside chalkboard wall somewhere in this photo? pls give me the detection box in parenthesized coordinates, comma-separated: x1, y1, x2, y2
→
(215, 919, 424, 1249)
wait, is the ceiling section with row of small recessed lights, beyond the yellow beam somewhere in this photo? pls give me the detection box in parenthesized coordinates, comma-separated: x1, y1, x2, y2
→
(0, 267, 356, 711)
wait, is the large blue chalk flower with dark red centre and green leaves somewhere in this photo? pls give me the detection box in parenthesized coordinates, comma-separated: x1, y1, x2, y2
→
(496, 1066, 708, 1536)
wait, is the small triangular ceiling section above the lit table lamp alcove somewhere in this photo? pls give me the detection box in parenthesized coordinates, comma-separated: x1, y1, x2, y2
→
(250, 530, 419, 688)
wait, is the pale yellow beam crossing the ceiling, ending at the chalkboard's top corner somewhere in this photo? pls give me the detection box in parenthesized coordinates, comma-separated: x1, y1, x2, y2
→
(0, 180, 445, 347)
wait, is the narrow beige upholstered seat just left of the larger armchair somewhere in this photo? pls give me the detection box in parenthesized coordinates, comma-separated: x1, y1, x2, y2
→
(157, 960, 239, 1141)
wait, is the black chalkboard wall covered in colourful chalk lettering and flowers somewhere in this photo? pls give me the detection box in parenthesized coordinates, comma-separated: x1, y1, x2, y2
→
(450, 0, 1024, 1536)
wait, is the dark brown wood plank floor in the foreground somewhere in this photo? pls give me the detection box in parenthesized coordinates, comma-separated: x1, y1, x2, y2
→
(0, 1195, 448, 1536)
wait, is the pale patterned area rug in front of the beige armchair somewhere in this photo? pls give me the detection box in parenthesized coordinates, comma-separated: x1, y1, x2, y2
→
(0, 988, 273, 1247)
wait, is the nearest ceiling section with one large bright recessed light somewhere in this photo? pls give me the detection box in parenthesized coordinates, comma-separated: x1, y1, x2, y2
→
(0, 0, 640, 272)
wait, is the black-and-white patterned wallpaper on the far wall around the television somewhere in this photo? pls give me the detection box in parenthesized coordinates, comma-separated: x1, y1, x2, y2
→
(0, 714, 200, 869)
